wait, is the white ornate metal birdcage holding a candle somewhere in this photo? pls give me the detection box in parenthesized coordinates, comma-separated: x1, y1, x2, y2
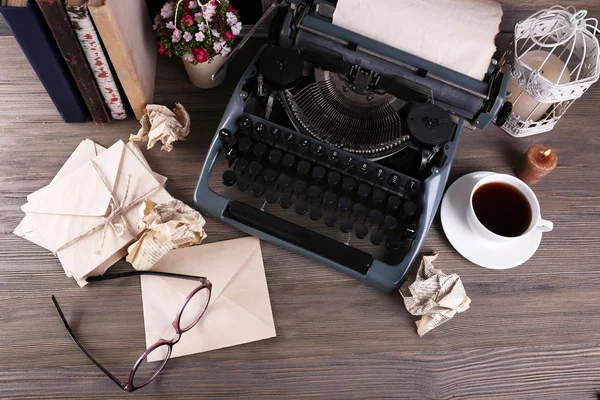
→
(501, 6, 600, 137)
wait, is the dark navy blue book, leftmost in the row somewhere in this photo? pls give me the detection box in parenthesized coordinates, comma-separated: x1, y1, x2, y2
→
(0, 0, 89, 123)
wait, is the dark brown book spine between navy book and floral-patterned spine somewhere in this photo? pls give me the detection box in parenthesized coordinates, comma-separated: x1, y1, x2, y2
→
(36, 0, 110, 125)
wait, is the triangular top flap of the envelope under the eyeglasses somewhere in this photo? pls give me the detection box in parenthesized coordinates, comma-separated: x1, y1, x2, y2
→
(152, 237, 260, 304)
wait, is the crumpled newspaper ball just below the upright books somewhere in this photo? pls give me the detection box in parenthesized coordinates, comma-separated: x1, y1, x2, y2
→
(129, 103, 190, 151)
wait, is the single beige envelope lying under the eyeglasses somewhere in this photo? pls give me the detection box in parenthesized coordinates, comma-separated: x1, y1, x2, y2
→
(141, 237, 276, 361)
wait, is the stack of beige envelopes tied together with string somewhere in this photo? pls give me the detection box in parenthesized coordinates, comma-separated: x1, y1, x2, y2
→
(14, 140, 172, 286)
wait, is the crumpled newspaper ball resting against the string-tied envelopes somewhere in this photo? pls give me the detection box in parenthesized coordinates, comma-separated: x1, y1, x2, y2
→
(126, 199, 206, 271)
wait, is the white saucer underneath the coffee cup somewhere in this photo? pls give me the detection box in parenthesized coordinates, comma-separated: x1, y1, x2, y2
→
(440, 171, 542, 269)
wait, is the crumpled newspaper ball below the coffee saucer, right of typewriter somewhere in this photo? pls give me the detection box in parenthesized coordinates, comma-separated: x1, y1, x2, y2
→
(400, 252, 471, 336)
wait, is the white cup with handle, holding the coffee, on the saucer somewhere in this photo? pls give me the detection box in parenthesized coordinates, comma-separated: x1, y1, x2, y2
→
(467, 174, 554, 242)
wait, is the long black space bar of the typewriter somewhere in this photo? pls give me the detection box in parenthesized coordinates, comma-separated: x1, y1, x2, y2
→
(225, 201, 373, 275)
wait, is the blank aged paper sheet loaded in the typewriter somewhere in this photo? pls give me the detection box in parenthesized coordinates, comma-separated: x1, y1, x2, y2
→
(333, 0, 502, 80)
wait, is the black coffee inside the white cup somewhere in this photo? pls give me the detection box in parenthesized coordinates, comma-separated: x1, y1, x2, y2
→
(473, 182, 532, 237)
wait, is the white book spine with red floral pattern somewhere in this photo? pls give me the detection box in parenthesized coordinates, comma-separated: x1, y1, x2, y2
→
(66, 5, 127, 120)
